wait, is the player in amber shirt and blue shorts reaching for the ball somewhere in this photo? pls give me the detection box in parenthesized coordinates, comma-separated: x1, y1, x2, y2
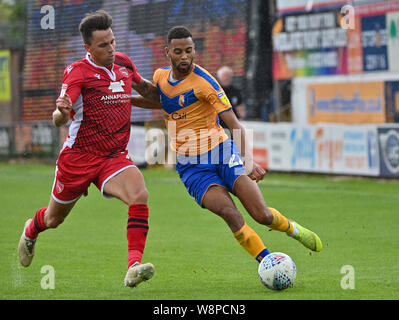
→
(132, 26, 322, 268)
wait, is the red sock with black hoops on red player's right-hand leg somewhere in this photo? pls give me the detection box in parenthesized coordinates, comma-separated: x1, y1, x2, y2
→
(126, 204, 148, 268)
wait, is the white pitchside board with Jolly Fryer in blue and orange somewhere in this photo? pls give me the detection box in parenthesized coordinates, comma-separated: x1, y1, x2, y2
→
(291, 125, 379, 176)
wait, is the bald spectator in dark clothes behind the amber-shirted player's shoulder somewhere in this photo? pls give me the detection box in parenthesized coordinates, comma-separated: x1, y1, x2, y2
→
(216, 66, 246, 128)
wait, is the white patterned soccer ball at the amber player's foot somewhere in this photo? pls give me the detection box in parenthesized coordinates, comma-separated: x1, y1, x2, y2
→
(258, 252, 296, 290)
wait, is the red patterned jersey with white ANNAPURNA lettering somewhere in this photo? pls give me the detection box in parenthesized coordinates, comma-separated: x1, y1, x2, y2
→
(60, 52, 141, 157)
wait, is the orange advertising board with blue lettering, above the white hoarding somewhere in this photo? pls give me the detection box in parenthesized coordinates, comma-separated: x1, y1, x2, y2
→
(307, 81, 386, 124)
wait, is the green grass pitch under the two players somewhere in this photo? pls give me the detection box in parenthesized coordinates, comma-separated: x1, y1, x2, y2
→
(0, 163, 399, 300)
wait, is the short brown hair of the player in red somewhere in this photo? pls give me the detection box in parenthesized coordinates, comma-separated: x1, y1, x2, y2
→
(79, 10, 112, 44)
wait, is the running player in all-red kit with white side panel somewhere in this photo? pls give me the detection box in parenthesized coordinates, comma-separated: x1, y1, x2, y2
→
(18, 10, 159, 287)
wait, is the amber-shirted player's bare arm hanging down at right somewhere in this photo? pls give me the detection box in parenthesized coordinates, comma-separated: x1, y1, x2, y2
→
(219, 109, 266, 182)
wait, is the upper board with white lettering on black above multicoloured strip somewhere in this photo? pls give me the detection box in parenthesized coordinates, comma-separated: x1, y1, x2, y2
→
(273, 11, 348, 79)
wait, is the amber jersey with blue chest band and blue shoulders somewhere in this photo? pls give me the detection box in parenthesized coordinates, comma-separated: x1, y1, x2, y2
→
(153, 64, 231, 156)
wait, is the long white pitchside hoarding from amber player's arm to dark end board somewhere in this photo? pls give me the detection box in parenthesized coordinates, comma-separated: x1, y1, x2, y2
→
(243, 122, 380, 176)
